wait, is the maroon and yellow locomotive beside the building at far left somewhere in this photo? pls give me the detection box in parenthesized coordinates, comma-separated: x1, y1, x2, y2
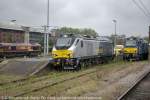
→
(0, 43, 41, 58)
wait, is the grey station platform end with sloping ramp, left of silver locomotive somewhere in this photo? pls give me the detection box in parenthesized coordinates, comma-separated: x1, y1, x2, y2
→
(0, 58, 52, 76)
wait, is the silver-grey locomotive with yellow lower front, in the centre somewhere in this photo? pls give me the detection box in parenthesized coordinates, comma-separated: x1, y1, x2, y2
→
(52, 36, 114, 70)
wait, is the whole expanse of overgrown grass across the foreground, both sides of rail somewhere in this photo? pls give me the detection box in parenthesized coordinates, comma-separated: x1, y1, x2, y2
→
(0, 61, 147, 96)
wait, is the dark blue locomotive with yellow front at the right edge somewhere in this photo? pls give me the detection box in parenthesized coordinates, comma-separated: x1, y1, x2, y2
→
(123, 37, 148, 61)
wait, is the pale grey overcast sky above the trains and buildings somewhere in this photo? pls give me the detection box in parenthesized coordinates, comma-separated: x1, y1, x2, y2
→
(0, 0, 150, 36)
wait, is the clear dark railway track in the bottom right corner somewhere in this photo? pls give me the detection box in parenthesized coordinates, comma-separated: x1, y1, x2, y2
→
(117, 70, 150, 100)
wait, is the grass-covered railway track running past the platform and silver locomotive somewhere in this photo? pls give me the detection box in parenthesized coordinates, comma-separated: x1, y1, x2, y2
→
(0, 58, 111, 97)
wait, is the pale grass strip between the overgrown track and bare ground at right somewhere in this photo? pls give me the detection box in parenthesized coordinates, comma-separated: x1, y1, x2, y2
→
(22, 62, 148, 96)
